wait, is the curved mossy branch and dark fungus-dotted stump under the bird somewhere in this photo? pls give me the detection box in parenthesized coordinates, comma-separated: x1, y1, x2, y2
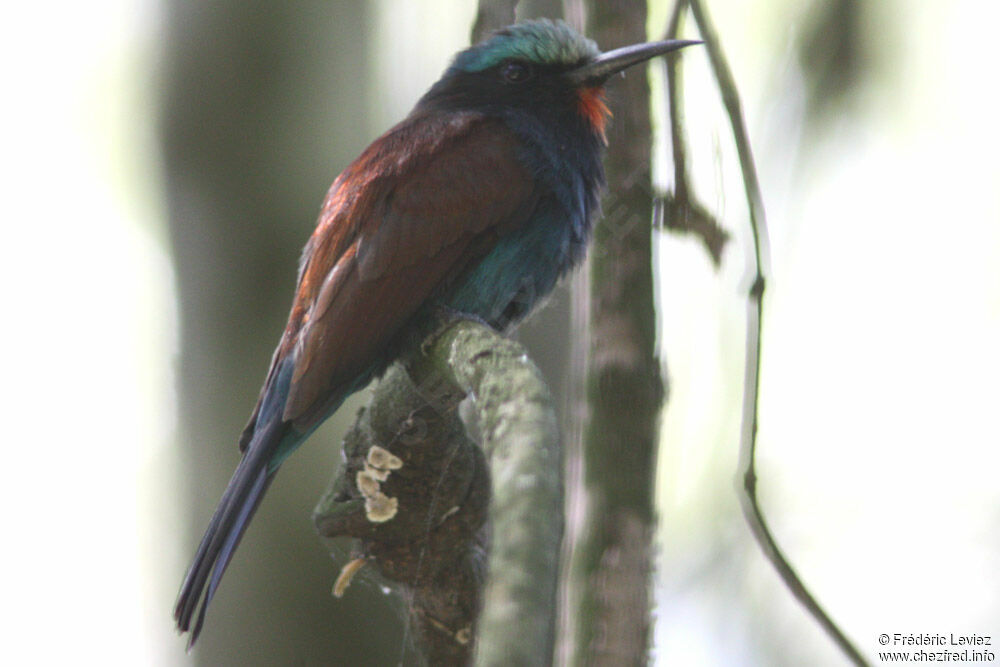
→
(316, 320, 563, 665)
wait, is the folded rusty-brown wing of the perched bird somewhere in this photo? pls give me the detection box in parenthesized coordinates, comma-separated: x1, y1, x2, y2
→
(264, 113, 535, 429)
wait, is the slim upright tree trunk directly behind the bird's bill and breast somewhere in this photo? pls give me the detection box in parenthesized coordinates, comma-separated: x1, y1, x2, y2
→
(571, 1, 664, 665)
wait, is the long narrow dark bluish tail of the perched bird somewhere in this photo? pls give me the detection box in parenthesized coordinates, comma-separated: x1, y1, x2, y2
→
(174, 420, 287, 648)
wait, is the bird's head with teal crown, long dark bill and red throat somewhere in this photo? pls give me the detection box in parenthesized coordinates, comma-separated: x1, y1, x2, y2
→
(424, 19, 698, 142)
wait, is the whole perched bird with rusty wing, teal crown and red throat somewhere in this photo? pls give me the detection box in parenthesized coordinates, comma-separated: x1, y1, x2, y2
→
(174, 19, 699, 649)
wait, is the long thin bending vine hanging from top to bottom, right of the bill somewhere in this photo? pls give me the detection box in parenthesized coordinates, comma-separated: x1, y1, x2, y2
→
(681, 0, 868, 665)
